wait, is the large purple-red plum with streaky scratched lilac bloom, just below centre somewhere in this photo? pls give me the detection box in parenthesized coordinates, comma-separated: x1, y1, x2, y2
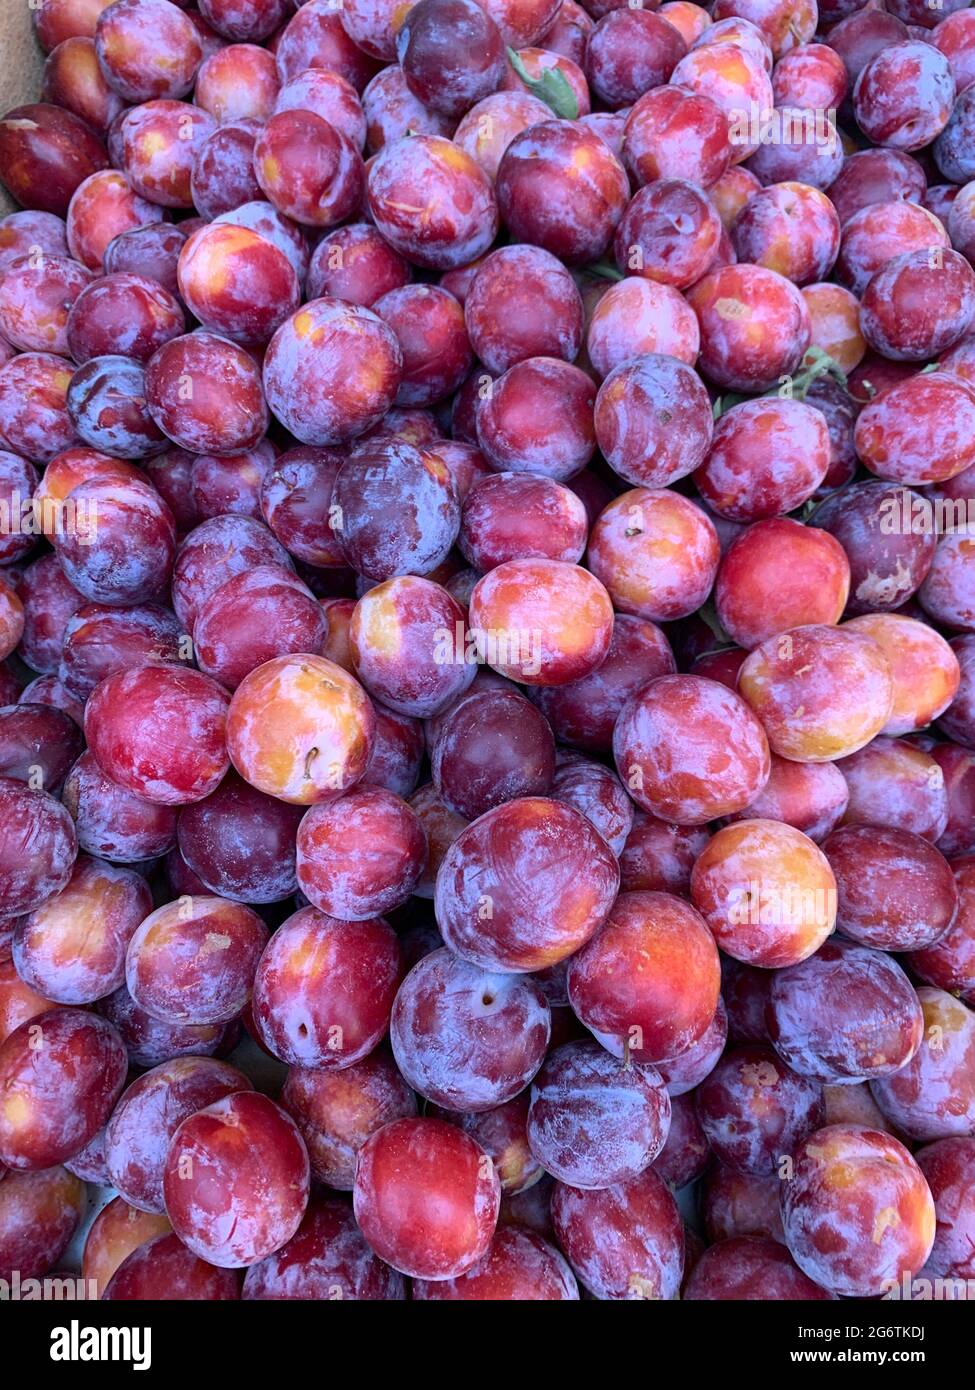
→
(435, 796, 619, 972)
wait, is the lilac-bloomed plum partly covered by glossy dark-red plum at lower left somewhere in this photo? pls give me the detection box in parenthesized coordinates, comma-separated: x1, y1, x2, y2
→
(106, 1056, 252, 1213)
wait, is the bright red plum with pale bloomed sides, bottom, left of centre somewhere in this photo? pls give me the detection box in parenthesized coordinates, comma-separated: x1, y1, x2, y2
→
(352, 1119, 501, 1280)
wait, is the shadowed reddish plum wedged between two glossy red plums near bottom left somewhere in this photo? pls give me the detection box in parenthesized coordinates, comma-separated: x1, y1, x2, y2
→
(280, 1048, 417, 1193)
